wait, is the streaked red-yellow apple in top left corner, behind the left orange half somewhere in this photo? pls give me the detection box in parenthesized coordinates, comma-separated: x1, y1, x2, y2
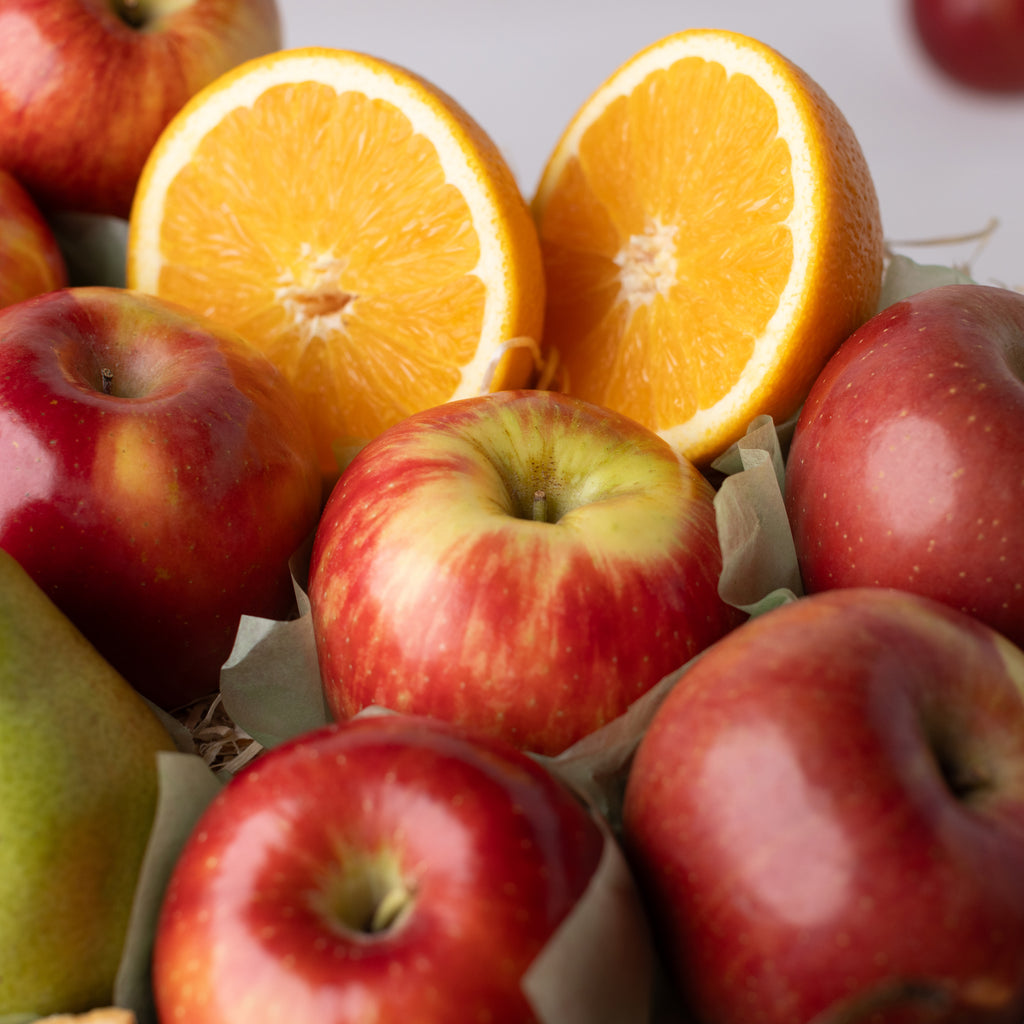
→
(0, 0, 281, 217)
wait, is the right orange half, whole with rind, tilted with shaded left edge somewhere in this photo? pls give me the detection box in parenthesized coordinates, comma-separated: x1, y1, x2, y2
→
(534, 29, 884, 464)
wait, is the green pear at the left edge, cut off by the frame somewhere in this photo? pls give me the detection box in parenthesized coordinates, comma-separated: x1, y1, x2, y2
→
(0, 550, 174, 1017)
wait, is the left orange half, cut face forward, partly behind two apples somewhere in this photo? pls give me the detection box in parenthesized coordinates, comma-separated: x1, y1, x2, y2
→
(127, 47, 544, 477)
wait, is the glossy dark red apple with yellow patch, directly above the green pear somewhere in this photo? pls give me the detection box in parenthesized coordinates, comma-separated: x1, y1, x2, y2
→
(0, 288, 322, 709)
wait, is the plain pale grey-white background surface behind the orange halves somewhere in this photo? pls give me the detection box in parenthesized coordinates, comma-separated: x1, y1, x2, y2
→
(279, 0, 1024, 289)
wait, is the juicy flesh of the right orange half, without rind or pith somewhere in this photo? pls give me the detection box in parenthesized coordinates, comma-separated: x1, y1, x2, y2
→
(542, 57, 794, 429)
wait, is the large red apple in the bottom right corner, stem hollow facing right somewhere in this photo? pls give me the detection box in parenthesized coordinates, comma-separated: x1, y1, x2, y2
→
(624, 588, 1024, 1024)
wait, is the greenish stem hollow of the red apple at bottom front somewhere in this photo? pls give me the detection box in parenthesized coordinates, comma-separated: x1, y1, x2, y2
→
(313, 853, 416, 936)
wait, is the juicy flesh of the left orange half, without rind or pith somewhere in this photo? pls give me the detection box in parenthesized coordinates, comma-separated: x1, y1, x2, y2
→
(152, 82, 484, 454)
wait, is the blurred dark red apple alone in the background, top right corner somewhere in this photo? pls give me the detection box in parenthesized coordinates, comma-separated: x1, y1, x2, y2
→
(909, 0, 1024, 92)
